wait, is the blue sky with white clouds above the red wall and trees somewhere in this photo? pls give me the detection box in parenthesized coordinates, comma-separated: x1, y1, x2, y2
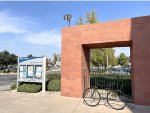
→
(0, 1, 150, 57)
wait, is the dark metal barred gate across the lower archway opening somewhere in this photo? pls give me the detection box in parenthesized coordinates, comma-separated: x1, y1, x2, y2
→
(83, 68, 132, 102)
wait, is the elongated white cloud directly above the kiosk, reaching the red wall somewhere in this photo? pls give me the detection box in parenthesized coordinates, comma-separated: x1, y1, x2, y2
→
(19, 30, 61, 47)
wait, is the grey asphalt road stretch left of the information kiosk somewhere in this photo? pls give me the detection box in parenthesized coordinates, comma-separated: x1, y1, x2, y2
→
(0, 74, 17, 91)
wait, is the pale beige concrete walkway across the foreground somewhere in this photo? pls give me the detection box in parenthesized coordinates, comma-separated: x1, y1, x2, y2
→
(0, 91, 150, 113)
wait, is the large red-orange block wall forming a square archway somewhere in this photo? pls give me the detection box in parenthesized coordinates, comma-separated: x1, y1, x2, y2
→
(61, 16, 150, 105)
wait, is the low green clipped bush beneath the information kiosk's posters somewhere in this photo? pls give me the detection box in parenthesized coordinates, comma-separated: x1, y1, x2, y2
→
(17, 83, 42, 93)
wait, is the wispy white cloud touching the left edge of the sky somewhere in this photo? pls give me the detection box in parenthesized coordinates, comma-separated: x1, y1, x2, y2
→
(0, 10, 34, 34)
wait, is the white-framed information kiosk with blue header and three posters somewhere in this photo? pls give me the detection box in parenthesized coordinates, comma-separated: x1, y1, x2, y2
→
(17, 57, 46, 92)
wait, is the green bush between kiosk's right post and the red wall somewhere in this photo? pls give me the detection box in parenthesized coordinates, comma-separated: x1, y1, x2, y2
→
(47, 79, 61, 91)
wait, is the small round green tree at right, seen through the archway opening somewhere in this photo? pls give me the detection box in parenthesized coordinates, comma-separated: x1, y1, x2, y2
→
(117, 53, 129, 66)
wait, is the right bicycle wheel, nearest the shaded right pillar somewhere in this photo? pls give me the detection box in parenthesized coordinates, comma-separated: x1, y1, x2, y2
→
(107, 90, 127, 110)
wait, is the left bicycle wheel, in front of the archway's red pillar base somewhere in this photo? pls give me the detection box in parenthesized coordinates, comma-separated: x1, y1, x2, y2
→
(83, 88, 101, 106)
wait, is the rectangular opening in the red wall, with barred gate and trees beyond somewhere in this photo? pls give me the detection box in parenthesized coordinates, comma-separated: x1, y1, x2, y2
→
(82, 42, 133, 102)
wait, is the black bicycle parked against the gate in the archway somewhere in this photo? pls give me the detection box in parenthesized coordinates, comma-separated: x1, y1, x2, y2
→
(83, 84, 127, 110)
